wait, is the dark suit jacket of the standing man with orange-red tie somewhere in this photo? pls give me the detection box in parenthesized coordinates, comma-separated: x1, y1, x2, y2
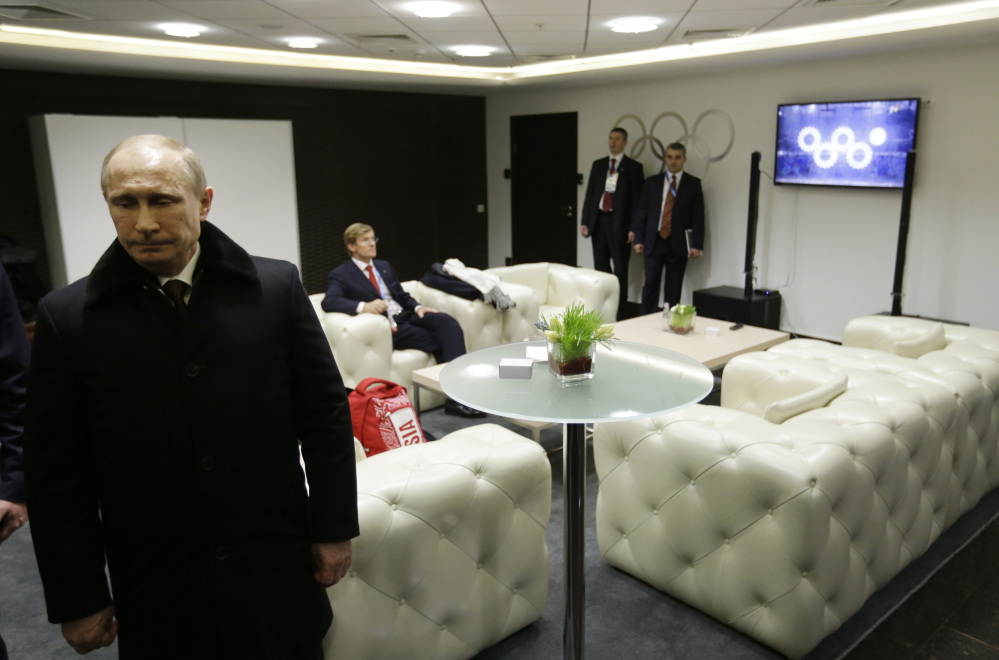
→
(631, 172, 704, 256)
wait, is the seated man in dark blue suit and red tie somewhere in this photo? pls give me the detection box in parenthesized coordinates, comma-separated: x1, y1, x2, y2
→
(322, 222, 485, 417)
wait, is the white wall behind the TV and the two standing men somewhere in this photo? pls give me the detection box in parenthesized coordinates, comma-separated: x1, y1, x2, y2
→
(486, 45, 999, 340)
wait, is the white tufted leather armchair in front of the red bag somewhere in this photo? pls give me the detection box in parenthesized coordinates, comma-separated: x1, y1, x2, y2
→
(324, 424, 551, 660)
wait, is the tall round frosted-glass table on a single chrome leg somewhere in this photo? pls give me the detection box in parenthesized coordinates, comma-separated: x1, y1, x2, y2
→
(440, 341, 713, 660)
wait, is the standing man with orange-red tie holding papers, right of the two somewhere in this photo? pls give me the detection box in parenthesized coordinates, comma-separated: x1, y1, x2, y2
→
(631, 142, 704, 314)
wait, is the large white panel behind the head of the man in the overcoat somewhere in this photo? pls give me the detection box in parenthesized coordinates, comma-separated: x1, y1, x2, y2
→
(31, 115, 301, 286)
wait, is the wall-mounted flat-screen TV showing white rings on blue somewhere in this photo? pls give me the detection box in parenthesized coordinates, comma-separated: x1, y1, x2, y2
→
(774, 99, 919, 188)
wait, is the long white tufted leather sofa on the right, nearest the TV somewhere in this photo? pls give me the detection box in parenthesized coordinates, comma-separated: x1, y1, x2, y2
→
(594, 317, 999, 658)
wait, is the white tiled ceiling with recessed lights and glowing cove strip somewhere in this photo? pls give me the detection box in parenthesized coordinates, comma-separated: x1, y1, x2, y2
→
(0, 0, 999, 86)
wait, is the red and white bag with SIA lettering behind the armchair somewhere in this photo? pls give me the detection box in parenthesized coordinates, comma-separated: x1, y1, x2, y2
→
(348, 378, 427, 456)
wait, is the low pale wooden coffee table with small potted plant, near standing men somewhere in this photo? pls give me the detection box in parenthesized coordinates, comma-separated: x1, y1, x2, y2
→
(614, 313, 790, 371)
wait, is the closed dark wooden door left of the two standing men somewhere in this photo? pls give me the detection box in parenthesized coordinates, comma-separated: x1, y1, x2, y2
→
(510, 112, 579, 266)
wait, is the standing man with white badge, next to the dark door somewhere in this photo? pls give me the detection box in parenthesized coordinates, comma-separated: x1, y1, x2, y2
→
(579, 128, 645, 319)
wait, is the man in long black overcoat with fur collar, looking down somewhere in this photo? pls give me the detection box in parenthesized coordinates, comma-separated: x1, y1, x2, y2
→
(24, 136, 358, 660)
